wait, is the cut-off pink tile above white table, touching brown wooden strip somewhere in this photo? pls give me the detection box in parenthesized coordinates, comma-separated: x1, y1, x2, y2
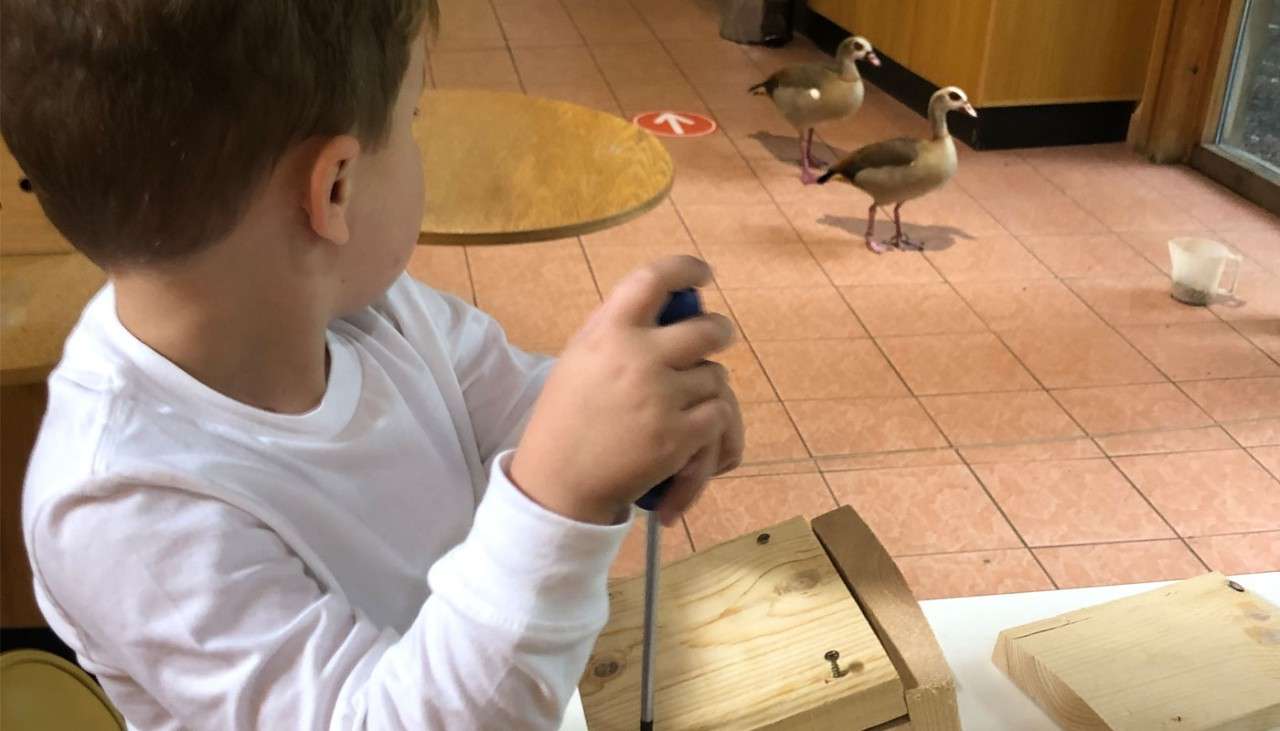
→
(895, 548, 1053, 600)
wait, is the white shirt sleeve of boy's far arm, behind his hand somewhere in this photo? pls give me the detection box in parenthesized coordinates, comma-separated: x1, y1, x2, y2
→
(392, 275, 554, 466)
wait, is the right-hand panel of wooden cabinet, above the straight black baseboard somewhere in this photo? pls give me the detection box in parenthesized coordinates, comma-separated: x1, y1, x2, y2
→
(982, 0, 1160, 106)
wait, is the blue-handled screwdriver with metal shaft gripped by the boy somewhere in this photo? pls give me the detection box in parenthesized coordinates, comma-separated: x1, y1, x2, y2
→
(636, 289, 703, 731)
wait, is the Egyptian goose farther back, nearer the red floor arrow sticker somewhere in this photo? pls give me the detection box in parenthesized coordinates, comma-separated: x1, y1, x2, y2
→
(748, 36, 879, 184)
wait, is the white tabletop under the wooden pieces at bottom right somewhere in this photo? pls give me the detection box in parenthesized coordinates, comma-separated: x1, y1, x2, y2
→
(561, 571, 1280, 731)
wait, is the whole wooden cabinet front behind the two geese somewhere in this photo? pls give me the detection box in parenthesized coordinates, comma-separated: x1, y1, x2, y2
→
(809, 0, 1160, 108)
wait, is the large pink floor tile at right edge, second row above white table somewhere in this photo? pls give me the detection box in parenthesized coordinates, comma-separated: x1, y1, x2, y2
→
(1116, 449, 1280, 536)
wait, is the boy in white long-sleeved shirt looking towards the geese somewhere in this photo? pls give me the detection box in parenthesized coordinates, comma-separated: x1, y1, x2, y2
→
(0, 0, 742, 730)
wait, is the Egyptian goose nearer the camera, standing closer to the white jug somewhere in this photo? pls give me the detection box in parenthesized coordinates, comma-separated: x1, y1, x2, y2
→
(818, 86, 978, 253)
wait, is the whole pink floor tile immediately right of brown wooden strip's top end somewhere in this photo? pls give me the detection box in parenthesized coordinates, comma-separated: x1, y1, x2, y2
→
(827, 465, 1021, 556)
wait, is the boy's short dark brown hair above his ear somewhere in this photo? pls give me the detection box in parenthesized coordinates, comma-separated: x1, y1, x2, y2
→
(0, 0, 436, 266)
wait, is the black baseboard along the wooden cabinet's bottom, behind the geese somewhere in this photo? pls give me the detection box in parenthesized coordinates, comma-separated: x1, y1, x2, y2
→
(796, 8, 1137, 150)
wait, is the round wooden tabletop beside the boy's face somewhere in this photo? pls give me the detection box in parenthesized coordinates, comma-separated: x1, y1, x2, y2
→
(413, 90, 675, 245)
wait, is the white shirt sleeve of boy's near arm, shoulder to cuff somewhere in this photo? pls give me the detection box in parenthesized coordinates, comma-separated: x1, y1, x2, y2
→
(29, 458, 627, 731)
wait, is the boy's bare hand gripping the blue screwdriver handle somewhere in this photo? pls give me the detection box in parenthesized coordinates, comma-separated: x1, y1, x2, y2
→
(511, 256, 742, 524)
